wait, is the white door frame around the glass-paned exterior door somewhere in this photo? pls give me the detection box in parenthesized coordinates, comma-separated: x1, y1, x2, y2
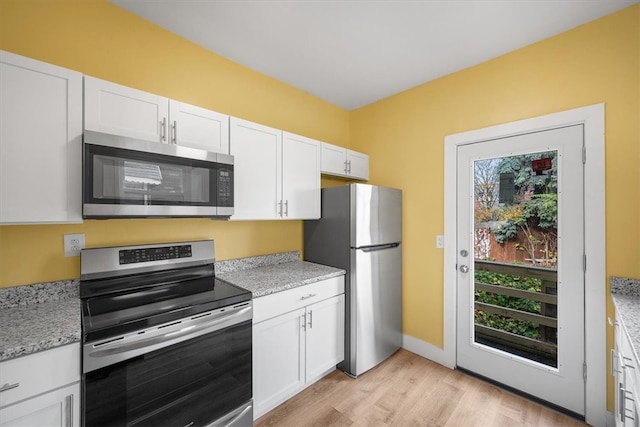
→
(440, 104, 607, 425)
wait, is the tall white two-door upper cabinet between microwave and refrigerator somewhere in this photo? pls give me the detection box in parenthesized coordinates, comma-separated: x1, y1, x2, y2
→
(230, 117, 320, 220)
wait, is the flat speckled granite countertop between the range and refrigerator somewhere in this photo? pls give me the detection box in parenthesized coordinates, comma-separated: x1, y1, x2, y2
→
(216, 261, 345, 298)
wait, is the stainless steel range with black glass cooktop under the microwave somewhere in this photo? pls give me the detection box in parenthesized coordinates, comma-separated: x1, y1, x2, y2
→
(80, 240, 253, 427)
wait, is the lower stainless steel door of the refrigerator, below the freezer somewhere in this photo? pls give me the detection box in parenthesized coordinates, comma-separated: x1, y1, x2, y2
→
(345, 243, 402, 376)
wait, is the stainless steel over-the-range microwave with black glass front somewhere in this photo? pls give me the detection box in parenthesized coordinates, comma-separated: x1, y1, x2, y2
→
(82, 131, 233, 219)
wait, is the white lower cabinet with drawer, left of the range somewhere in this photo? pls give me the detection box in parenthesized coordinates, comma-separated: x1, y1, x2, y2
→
(0, 344, 80, 427)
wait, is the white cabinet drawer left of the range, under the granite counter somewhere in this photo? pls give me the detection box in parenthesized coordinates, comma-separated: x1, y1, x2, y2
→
(0, 343, 80, 407)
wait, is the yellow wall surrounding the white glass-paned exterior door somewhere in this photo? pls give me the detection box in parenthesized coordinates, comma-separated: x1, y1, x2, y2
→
(351, 5, 640, 409)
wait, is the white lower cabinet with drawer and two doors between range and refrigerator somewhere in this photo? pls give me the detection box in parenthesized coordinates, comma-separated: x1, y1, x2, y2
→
(253, 276, 344, 418)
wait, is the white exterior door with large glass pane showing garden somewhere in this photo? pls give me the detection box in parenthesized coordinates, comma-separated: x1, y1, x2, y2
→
(456, 124, 585, 415)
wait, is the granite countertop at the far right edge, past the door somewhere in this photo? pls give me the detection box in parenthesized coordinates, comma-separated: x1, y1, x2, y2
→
(609, 277, 640, 360)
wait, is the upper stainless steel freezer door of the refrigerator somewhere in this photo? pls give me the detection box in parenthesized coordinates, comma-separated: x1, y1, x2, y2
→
(351, 184, 402, 248)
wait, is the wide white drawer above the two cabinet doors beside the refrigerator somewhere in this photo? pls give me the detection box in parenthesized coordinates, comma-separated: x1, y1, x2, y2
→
(253, 276, 344, 323)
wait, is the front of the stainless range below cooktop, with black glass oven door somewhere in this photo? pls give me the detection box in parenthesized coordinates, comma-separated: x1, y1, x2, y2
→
(83, 306, 253, 427)
